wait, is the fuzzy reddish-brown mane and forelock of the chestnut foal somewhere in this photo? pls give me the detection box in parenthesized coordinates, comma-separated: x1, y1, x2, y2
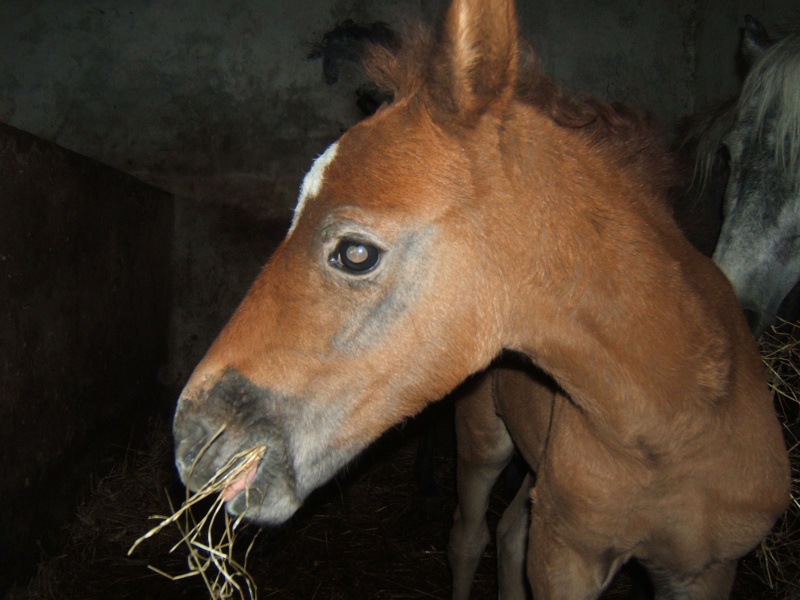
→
(364, 24, 685, 195)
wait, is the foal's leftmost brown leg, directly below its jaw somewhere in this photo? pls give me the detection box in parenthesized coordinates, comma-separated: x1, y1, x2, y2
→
(447, 372, 514, 600)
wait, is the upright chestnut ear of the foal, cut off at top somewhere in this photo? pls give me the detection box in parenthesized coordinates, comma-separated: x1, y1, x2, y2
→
(429, 0, 519, 120)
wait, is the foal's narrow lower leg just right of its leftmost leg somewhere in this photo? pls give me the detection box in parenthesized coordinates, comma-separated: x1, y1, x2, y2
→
(497, 473, 533, 600)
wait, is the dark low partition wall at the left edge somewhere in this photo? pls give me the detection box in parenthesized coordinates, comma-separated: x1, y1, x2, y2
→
(0, 125, 173, 595)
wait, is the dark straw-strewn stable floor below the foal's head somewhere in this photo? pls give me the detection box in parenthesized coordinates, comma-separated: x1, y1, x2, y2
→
(9, 386, 800, 600)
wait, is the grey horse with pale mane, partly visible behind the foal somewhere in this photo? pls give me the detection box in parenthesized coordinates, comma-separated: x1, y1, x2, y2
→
(683, 15, 800, 337)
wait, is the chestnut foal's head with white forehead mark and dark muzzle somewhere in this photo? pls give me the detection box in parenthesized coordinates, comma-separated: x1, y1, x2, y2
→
(174, 2, 528, 522)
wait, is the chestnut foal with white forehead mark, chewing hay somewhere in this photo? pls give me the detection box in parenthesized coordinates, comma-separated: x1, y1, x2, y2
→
(173, 0, 789, 599)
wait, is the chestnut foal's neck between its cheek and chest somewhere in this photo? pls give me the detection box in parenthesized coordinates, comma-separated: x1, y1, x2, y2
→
(500, 113, 730, 435)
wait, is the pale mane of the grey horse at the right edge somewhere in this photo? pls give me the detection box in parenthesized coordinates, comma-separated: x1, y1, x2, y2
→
(681, 32, 800, 192)
